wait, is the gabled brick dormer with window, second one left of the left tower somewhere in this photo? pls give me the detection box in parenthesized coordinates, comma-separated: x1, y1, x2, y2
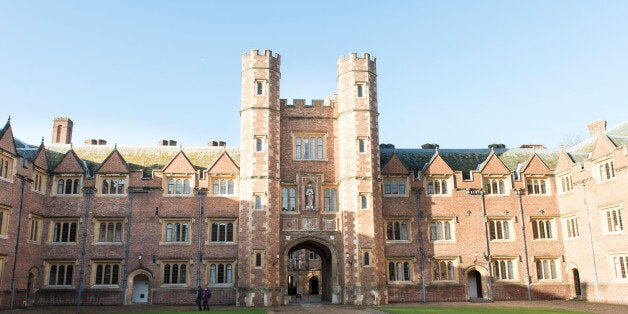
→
(162, 151, 196, 196)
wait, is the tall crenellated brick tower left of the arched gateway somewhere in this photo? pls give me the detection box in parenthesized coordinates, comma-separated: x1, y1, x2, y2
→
(236, 50, 281, 306)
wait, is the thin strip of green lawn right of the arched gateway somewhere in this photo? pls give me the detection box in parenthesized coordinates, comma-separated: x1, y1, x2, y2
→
(376, 307, 582, 314)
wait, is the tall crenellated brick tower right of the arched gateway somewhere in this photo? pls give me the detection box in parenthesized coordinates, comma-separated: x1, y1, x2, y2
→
(337, 53, 387, 304)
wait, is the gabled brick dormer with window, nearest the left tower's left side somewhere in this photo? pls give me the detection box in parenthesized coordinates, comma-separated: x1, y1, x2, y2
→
(207, 152, 240, 196)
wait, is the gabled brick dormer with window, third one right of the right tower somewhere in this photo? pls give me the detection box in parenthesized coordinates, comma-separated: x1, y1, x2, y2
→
(478, 151, 512, 195)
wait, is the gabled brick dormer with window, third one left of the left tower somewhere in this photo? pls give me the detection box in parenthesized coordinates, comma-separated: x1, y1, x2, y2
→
(95, 148, 130, 196)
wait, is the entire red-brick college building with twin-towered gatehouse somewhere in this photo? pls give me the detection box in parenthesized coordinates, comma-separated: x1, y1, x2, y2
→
(0, 50, 628, 308)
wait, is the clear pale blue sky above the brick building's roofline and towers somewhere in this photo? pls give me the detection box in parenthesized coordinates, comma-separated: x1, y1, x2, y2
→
(0, 0, 628, 148)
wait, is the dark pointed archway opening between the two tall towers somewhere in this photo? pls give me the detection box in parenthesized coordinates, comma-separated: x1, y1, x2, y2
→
(282, 237, 340, 303)
